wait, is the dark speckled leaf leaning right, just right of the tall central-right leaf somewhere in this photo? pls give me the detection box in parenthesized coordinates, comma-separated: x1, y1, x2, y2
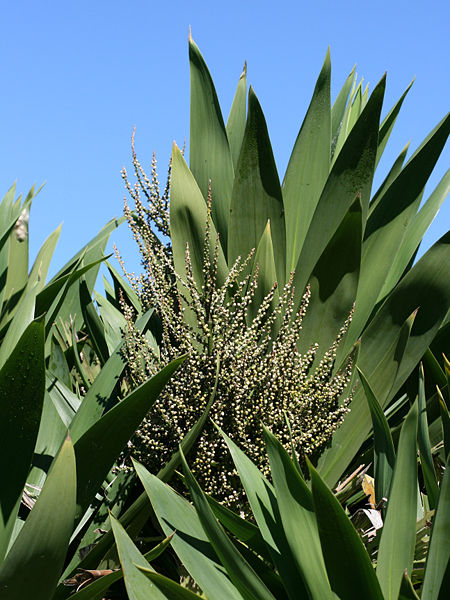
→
(294, 77, 385, 304)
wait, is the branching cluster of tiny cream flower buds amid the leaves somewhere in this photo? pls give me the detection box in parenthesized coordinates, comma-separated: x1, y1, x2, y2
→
(119, 142, 352, 508)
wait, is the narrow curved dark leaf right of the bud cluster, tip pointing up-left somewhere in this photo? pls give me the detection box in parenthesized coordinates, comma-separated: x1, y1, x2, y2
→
(358, 369, 395, 503)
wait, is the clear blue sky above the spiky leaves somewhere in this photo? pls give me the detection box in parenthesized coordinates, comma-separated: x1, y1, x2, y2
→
(0, 0, 450, 273)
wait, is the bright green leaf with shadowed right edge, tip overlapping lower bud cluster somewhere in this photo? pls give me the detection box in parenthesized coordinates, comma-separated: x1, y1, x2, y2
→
(264, 428, 331, 600)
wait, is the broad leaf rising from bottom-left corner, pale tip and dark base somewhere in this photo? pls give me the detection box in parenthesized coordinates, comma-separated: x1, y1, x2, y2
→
(0, 438, 76, 600)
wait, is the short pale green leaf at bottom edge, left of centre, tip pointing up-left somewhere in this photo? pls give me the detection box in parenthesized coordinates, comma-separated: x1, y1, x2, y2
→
(110, 515, 166, 600)
